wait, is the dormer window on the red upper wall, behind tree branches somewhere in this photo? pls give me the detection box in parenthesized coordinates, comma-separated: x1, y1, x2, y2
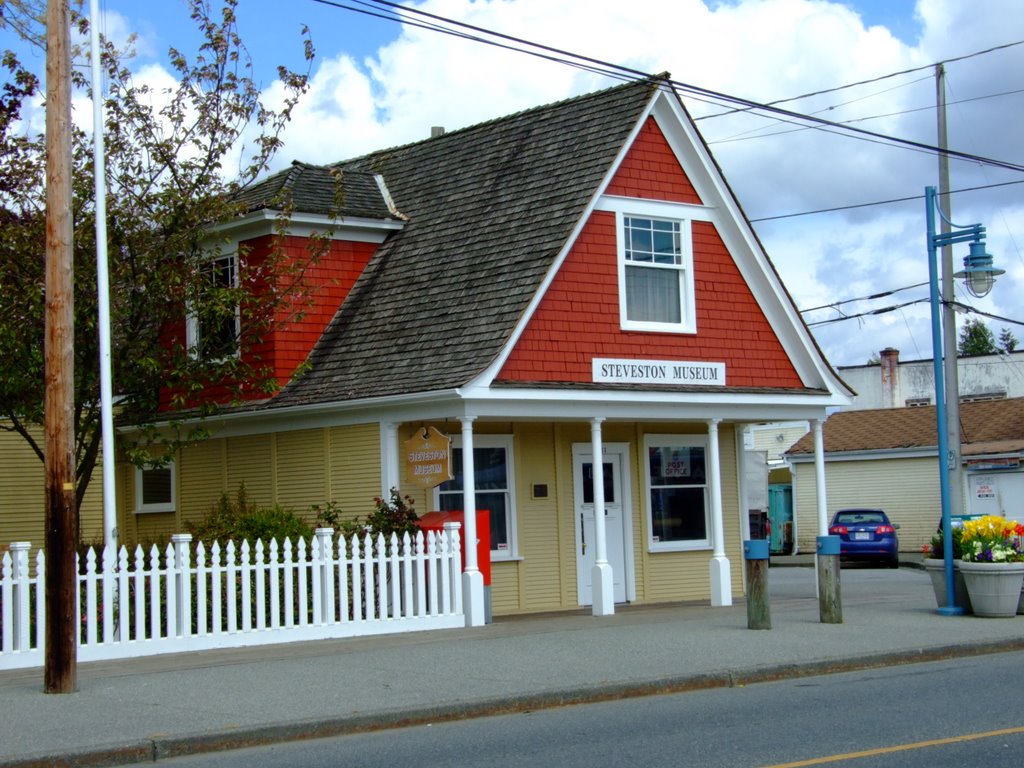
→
(185, 253, 241, 360)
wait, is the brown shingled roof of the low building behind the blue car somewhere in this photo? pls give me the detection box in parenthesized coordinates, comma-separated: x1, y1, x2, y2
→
(785, 397, 1024, 457)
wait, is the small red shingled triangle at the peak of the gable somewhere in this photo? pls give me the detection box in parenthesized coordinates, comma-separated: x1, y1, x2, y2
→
(607, 118, 700, 205)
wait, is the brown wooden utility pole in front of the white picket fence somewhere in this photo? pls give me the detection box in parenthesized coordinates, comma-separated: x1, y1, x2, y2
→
(43, 0, 78, 693)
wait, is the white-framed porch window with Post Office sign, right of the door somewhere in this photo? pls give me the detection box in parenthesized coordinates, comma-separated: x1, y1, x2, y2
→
(644, 434, 712, 552)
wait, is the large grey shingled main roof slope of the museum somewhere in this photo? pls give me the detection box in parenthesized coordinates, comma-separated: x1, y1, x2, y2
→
(267, 79, 663, 408)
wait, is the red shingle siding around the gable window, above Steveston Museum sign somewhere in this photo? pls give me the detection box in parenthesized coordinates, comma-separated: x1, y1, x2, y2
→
(498, 211, 803, 387)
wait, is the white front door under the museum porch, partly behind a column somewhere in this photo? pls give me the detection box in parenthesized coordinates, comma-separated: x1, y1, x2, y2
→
(572, 443, 632, 605)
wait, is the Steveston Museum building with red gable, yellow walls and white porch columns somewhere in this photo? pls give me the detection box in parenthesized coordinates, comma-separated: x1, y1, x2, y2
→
(114, 78, 851, 624)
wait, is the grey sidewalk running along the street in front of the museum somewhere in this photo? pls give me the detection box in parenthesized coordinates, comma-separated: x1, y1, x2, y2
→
(0, 558, 1024, 767)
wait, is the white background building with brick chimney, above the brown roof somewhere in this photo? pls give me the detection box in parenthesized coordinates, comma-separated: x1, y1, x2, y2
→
(839, 347, 1024, 411)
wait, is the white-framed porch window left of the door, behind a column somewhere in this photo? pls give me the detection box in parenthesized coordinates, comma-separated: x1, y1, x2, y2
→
(434, 435, 516, 560)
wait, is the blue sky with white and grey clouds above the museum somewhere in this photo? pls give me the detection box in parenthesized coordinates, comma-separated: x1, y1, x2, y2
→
(2, 0, 1024, 366)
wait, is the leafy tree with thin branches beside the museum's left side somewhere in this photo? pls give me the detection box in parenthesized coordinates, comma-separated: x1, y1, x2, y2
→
(0, 0, 316, 518)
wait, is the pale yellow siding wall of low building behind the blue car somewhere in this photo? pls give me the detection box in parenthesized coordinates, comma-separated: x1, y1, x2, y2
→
(793, 457, 941, 552)
